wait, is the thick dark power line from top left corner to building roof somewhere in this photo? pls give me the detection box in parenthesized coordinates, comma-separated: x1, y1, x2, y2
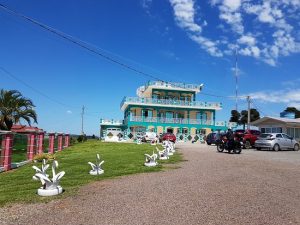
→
(0, 4, 162, 81)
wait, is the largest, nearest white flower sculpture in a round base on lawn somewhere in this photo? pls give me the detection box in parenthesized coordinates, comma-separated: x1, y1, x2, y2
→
(32, 160, 65, 196)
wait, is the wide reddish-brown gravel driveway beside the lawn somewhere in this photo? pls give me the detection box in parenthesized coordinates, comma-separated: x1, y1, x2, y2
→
(0, 144, 300, 225)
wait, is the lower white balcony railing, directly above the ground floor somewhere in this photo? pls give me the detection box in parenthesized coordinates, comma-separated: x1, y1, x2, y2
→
(129, 116, 213, 125)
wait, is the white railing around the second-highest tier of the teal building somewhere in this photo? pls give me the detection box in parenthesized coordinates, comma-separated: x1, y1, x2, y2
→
(120, 97, 222, 109)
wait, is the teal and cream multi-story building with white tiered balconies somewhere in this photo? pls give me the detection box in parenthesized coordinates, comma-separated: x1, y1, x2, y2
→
(100, 81, 234, 140)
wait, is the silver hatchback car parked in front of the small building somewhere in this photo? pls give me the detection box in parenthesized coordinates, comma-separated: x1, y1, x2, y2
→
(255, 133, 299, 151)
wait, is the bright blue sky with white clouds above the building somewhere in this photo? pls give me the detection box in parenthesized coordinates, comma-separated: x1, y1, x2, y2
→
(0, 0, 300, 135)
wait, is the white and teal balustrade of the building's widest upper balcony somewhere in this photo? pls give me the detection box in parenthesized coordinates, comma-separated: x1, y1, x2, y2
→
(120, 97, 222, 111)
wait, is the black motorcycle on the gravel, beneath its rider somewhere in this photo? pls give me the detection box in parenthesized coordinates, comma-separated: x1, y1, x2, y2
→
(217, 136, 243, 154)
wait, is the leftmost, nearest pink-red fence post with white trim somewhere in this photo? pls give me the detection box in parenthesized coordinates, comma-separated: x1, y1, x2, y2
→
(1, 131, 14, 171)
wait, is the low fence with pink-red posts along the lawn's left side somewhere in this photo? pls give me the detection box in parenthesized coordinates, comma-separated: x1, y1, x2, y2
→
(0, 131, 70, 171)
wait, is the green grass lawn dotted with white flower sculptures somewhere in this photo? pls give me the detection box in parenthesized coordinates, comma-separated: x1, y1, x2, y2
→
(0, 140, 182, 206)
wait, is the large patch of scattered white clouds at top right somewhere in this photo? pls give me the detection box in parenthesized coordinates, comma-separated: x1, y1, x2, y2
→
(169, 0, 300, 66)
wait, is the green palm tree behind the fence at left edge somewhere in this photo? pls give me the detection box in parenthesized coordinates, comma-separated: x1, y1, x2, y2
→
(0, 89, 37, 130)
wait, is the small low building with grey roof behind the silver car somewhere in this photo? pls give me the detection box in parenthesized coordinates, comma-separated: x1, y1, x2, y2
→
(251, 116, 300, 141)
